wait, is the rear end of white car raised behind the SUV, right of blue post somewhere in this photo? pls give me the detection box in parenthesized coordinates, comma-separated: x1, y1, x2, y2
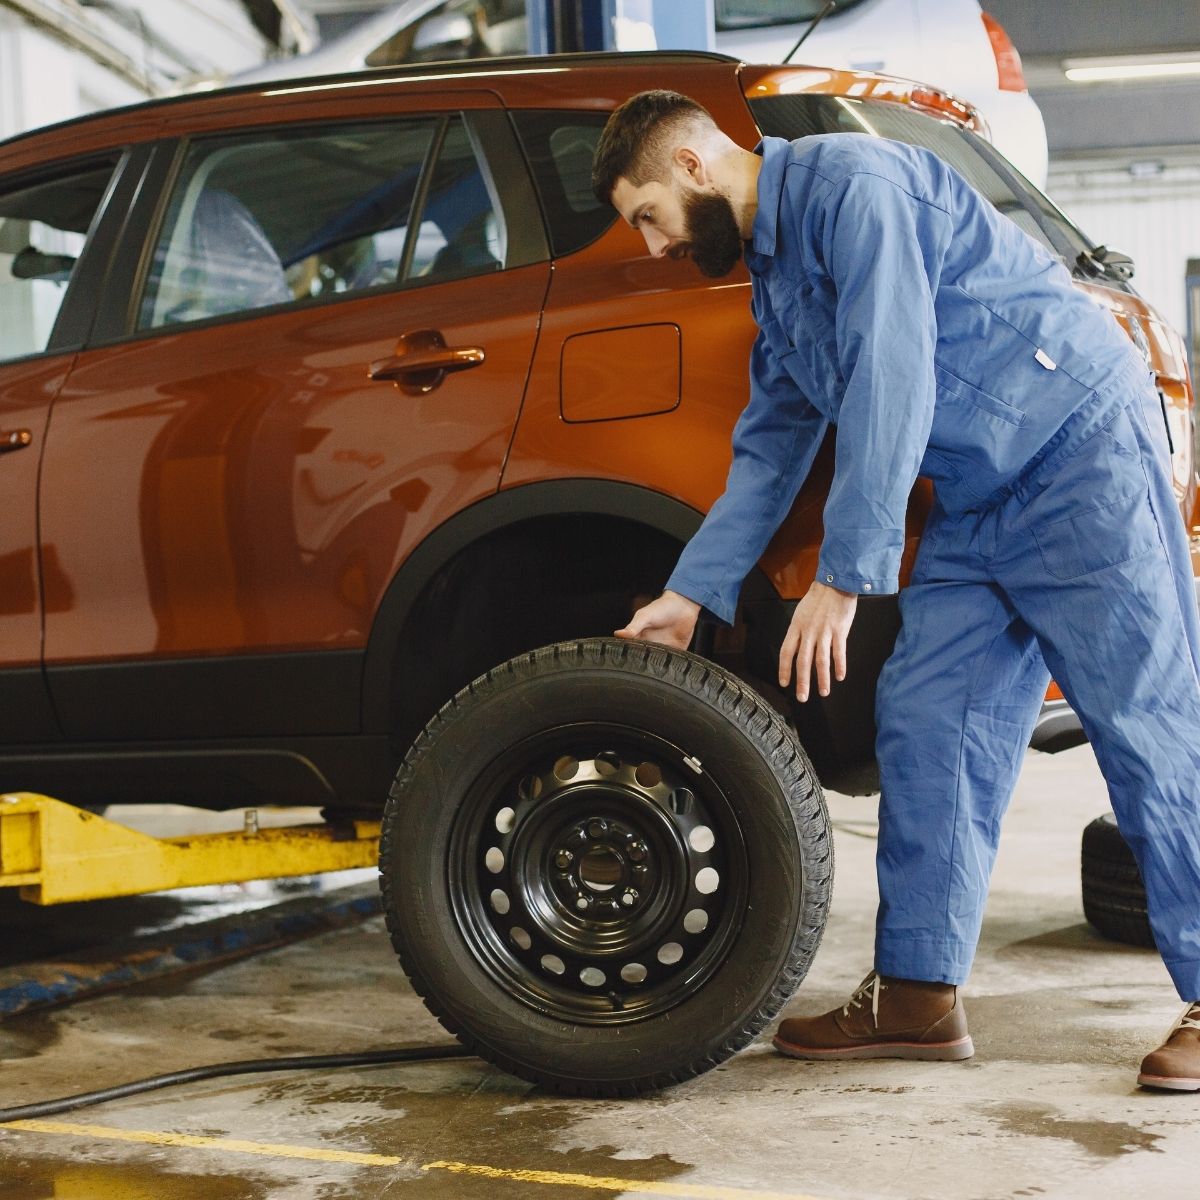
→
(715, 0, 1046, 188)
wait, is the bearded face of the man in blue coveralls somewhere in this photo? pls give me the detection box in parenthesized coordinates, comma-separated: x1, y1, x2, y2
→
(612, 178, 742, 280)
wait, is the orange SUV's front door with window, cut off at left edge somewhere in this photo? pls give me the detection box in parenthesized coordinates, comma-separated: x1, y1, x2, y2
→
(0, 156, 126, 744)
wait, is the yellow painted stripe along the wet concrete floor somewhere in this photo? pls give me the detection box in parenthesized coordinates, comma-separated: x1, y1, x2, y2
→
(0, 1121, 818, 1200)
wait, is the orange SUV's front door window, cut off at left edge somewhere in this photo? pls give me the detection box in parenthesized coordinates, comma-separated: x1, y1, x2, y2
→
(0, 162, 115, 360)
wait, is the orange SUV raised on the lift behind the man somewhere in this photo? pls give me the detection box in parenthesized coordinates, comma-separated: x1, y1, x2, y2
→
(0, 54, 1195, 811)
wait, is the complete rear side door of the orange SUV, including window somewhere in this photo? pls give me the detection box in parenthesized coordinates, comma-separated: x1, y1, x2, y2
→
(42, 96, 550, 740)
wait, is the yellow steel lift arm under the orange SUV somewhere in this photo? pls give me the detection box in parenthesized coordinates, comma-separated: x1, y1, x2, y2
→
(0, 792, 379, 905)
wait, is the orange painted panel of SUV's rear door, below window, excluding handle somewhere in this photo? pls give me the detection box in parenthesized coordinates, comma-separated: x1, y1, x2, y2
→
(42, 265, 548, 662)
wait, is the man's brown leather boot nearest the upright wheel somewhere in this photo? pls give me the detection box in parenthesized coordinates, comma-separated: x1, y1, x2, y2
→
(775, 971, 974, 1065)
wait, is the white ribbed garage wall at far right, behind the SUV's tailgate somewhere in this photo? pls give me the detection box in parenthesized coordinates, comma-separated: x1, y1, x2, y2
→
(1046, 151, 1200, 332)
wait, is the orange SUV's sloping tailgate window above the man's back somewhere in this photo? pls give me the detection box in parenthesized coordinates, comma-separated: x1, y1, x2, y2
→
(750, 96, 1108, 274)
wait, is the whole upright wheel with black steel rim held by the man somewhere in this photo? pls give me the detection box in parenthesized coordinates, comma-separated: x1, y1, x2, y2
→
(379, 640, 833, 1096)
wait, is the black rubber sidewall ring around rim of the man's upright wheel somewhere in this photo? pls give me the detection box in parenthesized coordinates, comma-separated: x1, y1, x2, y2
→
(382, 662, 823, 1081)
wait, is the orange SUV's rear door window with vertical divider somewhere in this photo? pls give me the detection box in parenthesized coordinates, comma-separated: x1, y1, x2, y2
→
(138, 116, 505, 329)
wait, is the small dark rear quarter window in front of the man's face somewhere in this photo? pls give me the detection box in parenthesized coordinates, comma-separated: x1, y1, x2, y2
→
(512, 110, 617, 258)
